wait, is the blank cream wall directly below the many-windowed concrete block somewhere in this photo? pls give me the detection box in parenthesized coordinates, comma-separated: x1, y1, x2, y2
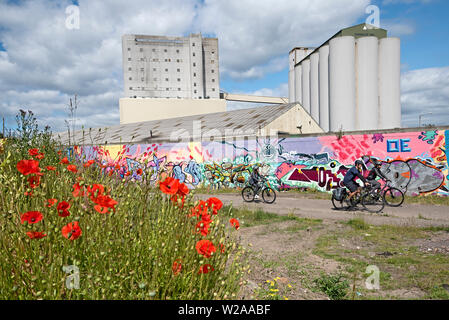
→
(119, 98, 226, 124)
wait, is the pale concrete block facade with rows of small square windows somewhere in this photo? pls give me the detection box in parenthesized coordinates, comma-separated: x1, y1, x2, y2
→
(122, 34, 220, 99)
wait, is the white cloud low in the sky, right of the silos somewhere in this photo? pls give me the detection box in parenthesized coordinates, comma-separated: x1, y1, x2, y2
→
(401, 67, 449, 127)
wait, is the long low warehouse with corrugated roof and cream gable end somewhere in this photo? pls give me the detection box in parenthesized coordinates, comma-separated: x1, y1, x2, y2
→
(54, 103, 323, 145)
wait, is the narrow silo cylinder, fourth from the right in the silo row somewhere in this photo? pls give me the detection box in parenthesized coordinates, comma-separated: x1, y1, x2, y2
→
(318, 45, 329, 132)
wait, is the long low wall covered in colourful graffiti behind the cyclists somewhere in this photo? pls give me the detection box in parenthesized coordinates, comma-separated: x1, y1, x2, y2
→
(74, 130, 449, 196)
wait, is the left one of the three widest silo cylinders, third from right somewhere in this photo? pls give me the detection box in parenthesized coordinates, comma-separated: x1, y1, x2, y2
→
(329, 36, 355, 132)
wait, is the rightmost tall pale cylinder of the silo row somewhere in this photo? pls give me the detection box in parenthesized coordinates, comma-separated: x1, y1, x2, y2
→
(379, 38, 401, 129)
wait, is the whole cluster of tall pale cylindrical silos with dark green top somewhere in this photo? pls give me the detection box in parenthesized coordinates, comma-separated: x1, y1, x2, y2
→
(289, 24, 401, 132)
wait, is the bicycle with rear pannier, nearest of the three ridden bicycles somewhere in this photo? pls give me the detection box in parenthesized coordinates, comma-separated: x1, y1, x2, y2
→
(331, 185, 385, 213)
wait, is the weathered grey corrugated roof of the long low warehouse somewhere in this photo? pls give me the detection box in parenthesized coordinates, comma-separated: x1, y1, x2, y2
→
(53, 103, 296, 145)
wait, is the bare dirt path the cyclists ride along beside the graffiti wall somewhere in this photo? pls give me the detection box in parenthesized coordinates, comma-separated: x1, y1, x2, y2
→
(197, 193, 449, 227)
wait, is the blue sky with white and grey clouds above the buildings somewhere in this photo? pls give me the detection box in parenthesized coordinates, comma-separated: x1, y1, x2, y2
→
(0, 0, 449, 132)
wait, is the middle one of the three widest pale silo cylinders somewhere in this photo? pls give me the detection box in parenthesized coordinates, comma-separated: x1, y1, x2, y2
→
(355, 37, 379, 130)
